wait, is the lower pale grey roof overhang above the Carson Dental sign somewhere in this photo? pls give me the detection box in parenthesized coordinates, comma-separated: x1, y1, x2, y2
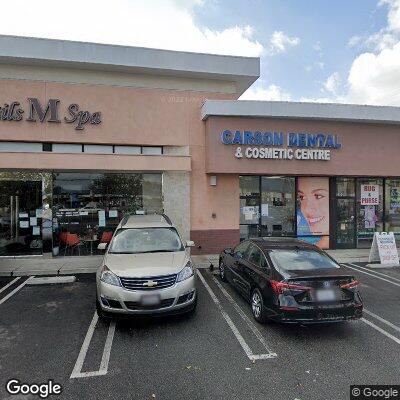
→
(201, 100, 400, 124)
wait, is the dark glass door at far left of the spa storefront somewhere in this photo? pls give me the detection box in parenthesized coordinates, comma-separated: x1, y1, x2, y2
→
(0, 181, 42, 256)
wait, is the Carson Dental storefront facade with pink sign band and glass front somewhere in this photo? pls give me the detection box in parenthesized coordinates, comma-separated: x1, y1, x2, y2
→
(202, 100, 400, 253)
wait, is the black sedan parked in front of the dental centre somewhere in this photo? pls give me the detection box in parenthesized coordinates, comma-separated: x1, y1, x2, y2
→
(219, 238, 363, 323)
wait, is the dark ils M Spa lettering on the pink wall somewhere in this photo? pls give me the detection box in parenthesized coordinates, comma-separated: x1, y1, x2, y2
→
(0, 97, 101, 131)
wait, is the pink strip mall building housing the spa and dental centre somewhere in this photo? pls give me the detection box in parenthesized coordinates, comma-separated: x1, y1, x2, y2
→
(0, 36, 400, 264)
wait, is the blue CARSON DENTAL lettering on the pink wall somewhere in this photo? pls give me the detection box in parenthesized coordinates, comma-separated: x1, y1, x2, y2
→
(221, 129, 342, 149)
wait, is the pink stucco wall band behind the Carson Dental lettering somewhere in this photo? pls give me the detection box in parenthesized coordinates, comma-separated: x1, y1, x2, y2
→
(206, 117, 400, 176)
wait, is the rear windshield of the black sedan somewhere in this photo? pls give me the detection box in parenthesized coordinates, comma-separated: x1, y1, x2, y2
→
(269, 249, 340, 271)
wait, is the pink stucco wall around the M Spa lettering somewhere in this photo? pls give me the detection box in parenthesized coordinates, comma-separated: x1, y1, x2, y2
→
(0, 80, 238, 234)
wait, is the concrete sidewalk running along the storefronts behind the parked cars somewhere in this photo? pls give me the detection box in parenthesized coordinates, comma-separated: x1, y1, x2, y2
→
(0, 249, 378, 276)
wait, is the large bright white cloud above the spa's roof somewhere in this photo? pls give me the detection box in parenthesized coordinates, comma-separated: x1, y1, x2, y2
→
(0, 0, 263, 56)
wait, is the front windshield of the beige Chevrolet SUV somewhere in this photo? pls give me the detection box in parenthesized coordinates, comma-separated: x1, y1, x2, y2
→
(109, 228, 184, 254)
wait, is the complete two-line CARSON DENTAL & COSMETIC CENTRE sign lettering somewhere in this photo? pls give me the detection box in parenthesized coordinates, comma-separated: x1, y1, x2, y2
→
(221, 129, 342, 161)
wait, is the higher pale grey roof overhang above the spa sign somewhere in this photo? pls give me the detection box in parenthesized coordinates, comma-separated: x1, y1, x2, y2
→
(0, 35, 260, 95)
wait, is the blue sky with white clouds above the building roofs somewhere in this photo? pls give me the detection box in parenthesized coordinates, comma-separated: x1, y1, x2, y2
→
(0, 0, 400, 106)
